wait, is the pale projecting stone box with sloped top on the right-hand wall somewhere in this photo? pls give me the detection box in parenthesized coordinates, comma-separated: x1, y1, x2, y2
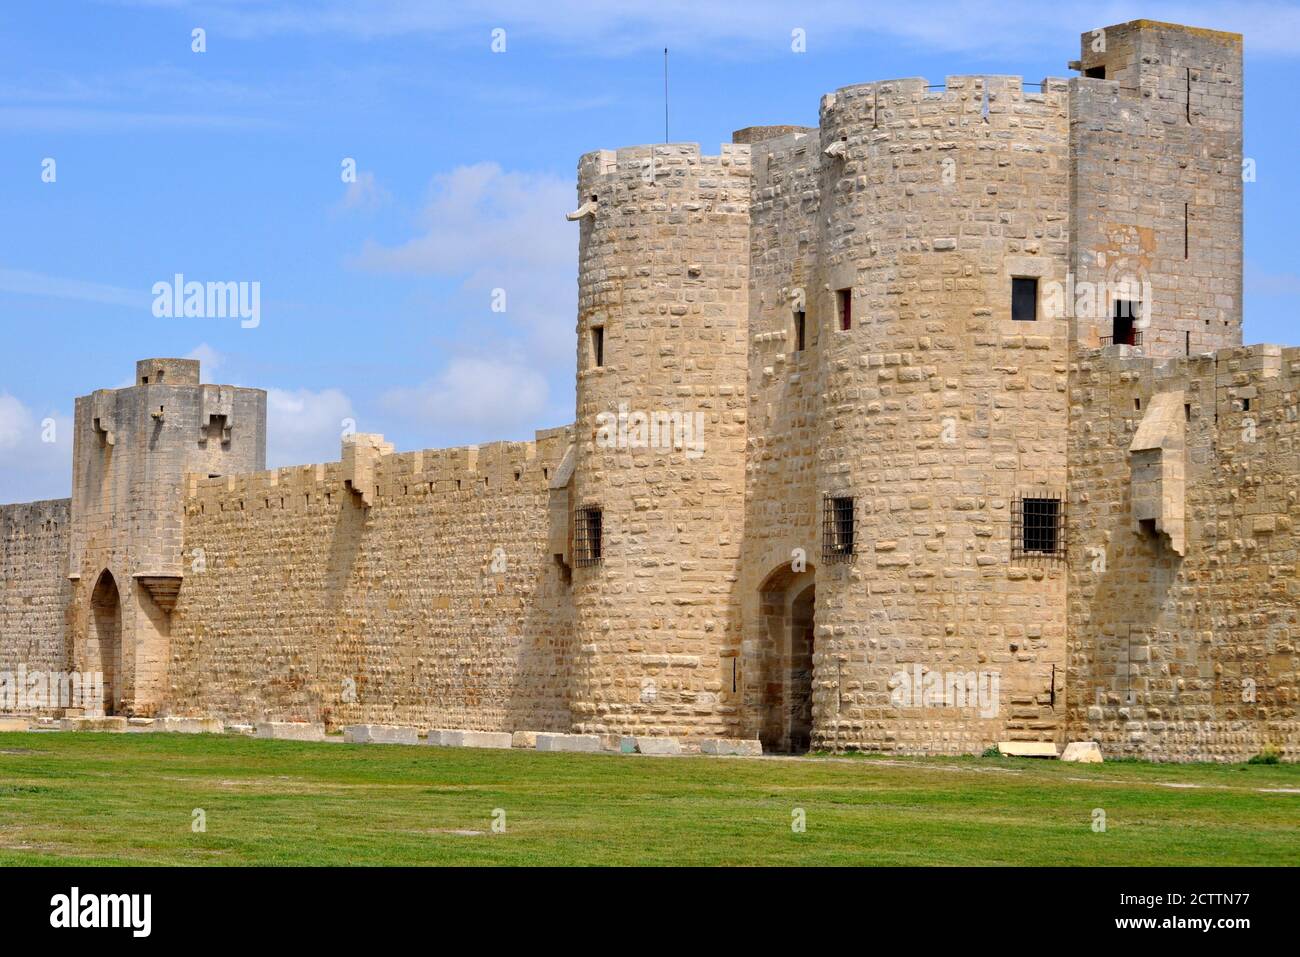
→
(1128, 391, 1187, 555)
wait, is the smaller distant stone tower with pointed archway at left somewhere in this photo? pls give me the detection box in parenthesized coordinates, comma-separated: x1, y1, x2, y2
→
(68, 359, 267, 715)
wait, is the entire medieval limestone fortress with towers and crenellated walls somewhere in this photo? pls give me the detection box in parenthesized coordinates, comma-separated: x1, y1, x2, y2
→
(0, 21, 1300, 761)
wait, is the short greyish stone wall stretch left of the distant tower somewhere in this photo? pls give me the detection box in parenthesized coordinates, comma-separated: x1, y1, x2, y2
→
(0, 498, 72, 674)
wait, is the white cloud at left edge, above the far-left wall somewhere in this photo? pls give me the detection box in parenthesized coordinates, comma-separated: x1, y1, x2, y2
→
(0, 393, 73, 503)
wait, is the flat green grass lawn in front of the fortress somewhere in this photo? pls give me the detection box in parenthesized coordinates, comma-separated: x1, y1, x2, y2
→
(0, 732, 1300, 866)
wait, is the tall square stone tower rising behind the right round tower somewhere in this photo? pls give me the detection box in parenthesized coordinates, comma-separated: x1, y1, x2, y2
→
(1070, 20, 1243, 358)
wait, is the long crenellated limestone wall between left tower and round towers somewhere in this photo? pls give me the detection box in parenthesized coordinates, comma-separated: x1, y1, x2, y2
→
(165, 429, 573, 731)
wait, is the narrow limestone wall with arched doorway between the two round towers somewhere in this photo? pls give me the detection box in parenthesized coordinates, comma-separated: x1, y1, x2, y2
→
(736, 127, 829, 750)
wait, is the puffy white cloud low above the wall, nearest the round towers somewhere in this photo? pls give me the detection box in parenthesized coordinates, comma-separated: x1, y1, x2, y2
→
(381, 358, 549, 441)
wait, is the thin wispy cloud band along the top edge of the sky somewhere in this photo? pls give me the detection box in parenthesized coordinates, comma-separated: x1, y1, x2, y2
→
(101, 0, 1300, 56)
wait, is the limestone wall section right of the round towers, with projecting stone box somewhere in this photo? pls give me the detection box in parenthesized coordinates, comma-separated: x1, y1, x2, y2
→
(1069, 346, 1300, 761)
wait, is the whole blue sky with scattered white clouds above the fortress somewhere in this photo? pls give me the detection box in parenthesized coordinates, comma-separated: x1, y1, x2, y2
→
(0, 0, 1300, 502)
